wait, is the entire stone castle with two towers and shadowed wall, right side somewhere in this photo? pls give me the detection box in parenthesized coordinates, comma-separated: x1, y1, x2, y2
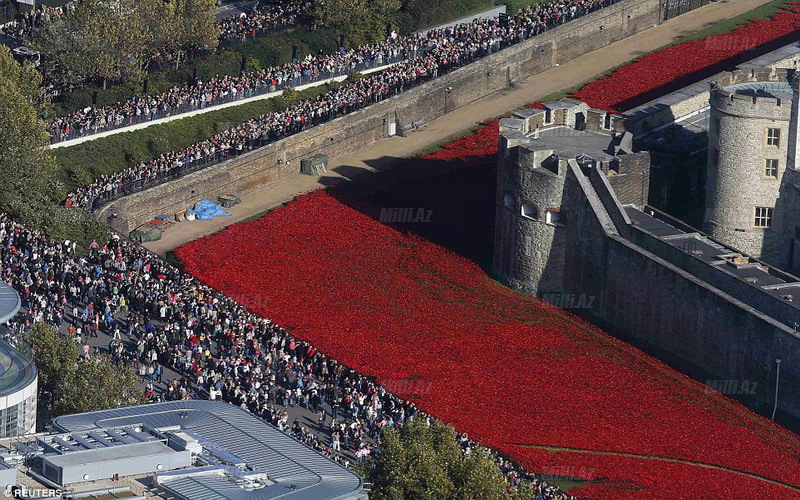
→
(494, 44, 800, 418)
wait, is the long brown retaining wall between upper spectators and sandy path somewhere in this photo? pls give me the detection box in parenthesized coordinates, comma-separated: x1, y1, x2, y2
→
(101, 0, 661, 233)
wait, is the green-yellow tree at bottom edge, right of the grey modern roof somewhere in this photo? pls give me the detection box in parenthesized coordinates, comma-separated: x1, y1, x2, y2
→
(367, 419, 506, 500)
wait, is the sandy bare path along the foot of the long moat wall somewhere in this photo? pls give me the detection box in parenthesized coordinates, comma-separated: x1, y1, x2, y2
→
(144, 0, 768, 255)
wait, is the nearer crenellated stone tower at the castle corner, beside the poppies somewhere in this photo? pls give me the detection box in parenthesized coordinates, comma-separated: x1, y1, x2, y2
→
(493, 99, 650, 296)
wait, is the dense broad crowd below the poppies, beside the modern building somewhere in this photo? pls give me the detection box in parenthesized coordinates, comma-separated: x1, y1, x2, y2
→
(0, 219, 569, 499)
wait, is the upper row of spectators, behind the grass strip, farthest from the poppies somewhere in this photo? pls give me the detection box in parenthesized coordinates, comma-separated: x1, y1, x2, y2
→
(51, 0, 616, 142)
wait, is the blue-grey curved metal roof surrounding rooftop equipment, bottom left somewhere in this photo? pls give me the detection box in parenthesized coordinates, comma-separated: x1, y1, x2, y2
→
(54, 400, 367, 500)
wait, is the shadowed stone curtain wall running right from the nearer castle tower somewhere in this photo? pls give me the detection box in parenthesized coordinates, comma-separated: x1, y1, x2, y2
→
(517, 162, 800, 418)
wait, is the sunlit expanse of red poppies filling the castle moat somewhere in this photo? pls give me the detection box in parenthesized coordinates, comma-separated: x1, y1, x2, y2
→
(176, 4, 800, 500)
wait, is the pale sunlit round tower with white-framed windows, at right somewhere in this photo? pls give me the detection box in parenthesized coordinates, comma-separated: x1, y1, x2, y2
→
(704, 68, 797, 268)
